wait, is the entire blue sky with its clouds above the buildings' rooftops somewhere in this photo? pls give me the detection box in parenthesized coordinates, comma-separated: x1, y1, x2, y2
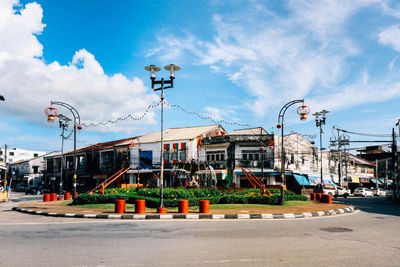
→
(0, 0, 400, 152)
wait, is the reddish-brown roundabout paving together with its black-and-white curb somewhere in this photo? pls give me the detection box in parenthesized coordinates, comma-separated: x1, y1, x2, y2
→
(13, 201, 356, 219)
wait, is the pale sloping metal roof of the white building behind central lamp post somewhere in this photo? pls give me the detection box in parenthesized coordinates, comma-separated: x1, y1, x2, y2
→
(120, 124, 224, 145)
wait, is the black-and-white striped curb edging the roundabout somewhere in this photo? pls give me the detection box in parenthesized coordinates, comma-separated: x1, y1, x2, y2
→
(12, 206, 356, 220)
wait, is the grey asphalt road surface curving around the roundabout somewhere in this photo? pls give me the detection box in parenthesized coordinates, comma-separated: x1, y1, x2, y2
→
(0, 196, 400, 266)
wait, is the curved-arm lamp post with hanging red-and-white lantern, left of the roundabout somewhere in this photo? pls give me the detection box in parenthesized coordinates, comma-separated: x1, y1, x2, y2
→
(45, 101, 82, 199)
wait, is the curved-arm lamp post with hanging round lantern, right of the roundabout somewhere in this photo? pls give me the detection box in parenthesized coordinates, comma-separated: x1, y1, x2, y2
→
(277, 99, 310, 205)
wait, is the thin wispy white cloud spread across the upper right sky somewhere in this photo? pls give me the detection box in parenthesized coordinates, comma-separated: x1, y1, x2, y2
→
(148, 0, 400, 120)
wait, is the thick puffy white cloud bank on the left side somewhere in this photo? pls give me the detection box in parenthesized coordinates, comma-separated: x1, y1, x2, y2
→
(0, 0, 159, 131)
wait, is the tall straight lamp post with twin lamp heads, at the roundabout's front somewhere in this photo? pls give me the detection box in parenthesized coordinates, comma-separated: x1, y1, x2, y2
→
(144, 64, 181, 212)
